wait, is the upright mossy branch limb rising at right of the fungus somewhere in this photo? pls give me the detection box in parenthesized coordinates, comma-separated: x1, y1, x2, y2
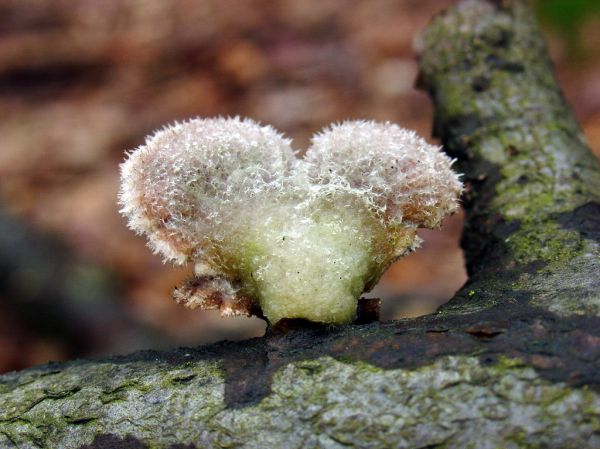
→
(421, 1, 600, 315)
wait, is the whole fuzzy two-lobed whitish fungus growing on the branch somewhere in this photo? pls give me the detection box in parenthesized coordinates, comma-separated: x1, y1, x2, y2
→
(119, 118, 462, 324)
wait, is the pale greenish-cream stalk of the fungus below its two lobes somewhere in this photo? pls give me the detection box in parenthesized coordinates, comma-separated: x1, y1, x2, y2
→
(228, 192, 414, 323)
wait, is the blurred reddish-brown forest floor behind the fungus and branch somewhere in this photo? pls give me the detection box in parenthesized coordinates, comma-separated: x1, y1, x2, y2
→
(0, 0, 600, 372)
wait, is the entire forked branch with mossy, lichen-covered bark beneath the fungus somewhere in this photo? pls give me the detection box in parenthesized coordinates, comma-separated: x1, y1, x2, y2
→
(0, 0, 600, 449)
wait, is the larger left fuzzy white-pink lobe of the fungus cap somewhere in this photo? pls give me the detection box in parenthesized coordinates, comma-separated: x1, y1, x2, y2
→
(119, 117, 296, 264)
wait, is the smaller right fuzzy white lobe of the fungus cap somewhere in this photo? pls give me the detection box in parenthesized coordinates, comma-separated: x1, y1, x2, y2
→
(304, 121, 462, 228)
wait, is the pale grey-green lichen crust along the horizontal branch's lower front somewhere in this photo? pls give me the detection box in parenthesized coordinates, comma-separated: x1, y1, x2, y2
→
(0, 356, 600, 449)
